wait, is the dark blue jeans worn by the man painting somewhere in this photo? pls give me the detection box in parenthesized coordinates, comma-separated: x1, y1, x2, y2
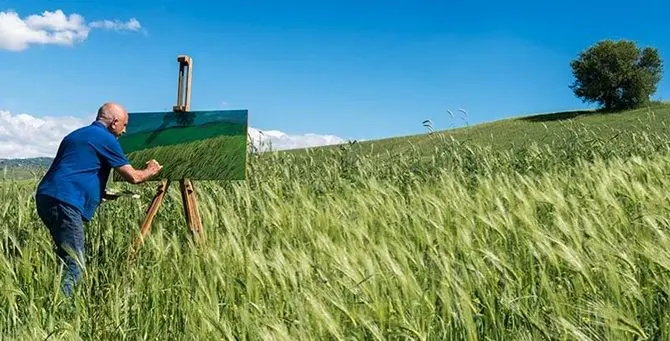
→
(35, 195, 84, 296)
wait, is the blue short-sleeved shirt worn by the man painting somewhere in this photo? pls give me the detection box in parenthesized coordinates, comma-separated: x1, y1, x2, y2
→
(36, 122, 129, 221)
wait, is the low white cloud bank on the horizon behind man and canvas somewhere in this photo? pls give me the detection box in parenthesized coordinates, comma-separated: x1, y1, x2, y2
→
(0, 110, 345, 159)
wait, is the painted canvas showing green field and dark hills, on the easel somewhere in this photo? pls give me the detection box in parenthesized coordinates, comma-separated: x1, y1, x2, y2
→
(115, 110, 248, 180)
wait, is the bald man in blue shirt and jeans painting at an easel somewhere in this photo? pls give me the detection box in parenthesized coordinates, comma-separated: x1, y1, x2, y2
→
(35, 103, 162, 296)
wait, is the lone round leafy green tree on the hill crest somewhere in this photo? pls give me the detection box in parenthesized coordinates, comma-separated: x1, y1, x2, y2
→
(570, 40, 663, 110)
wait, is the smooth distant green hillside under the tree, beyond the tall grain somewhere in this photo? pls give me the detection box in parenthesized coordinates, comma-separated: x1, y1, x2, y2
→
(287, 103, 670, 155)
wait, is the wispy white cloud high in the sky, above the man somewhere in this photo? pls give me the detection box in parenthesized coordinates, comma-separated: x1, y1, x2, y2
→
(0, 9, 142, 52)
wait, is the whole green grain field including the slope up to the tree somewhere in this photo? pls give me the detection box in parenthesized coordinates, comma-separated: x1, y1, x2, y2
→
(0, 105, 670, 340)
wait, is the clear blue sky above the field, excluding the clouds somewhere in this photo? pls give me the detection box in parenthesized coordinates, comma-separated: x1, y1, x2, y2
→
(0, 0, 670, 157)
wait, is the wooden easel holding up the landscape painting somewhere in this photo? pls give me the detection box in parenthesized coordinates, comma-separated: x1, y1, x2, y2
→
(133, 55, 203, 251)
